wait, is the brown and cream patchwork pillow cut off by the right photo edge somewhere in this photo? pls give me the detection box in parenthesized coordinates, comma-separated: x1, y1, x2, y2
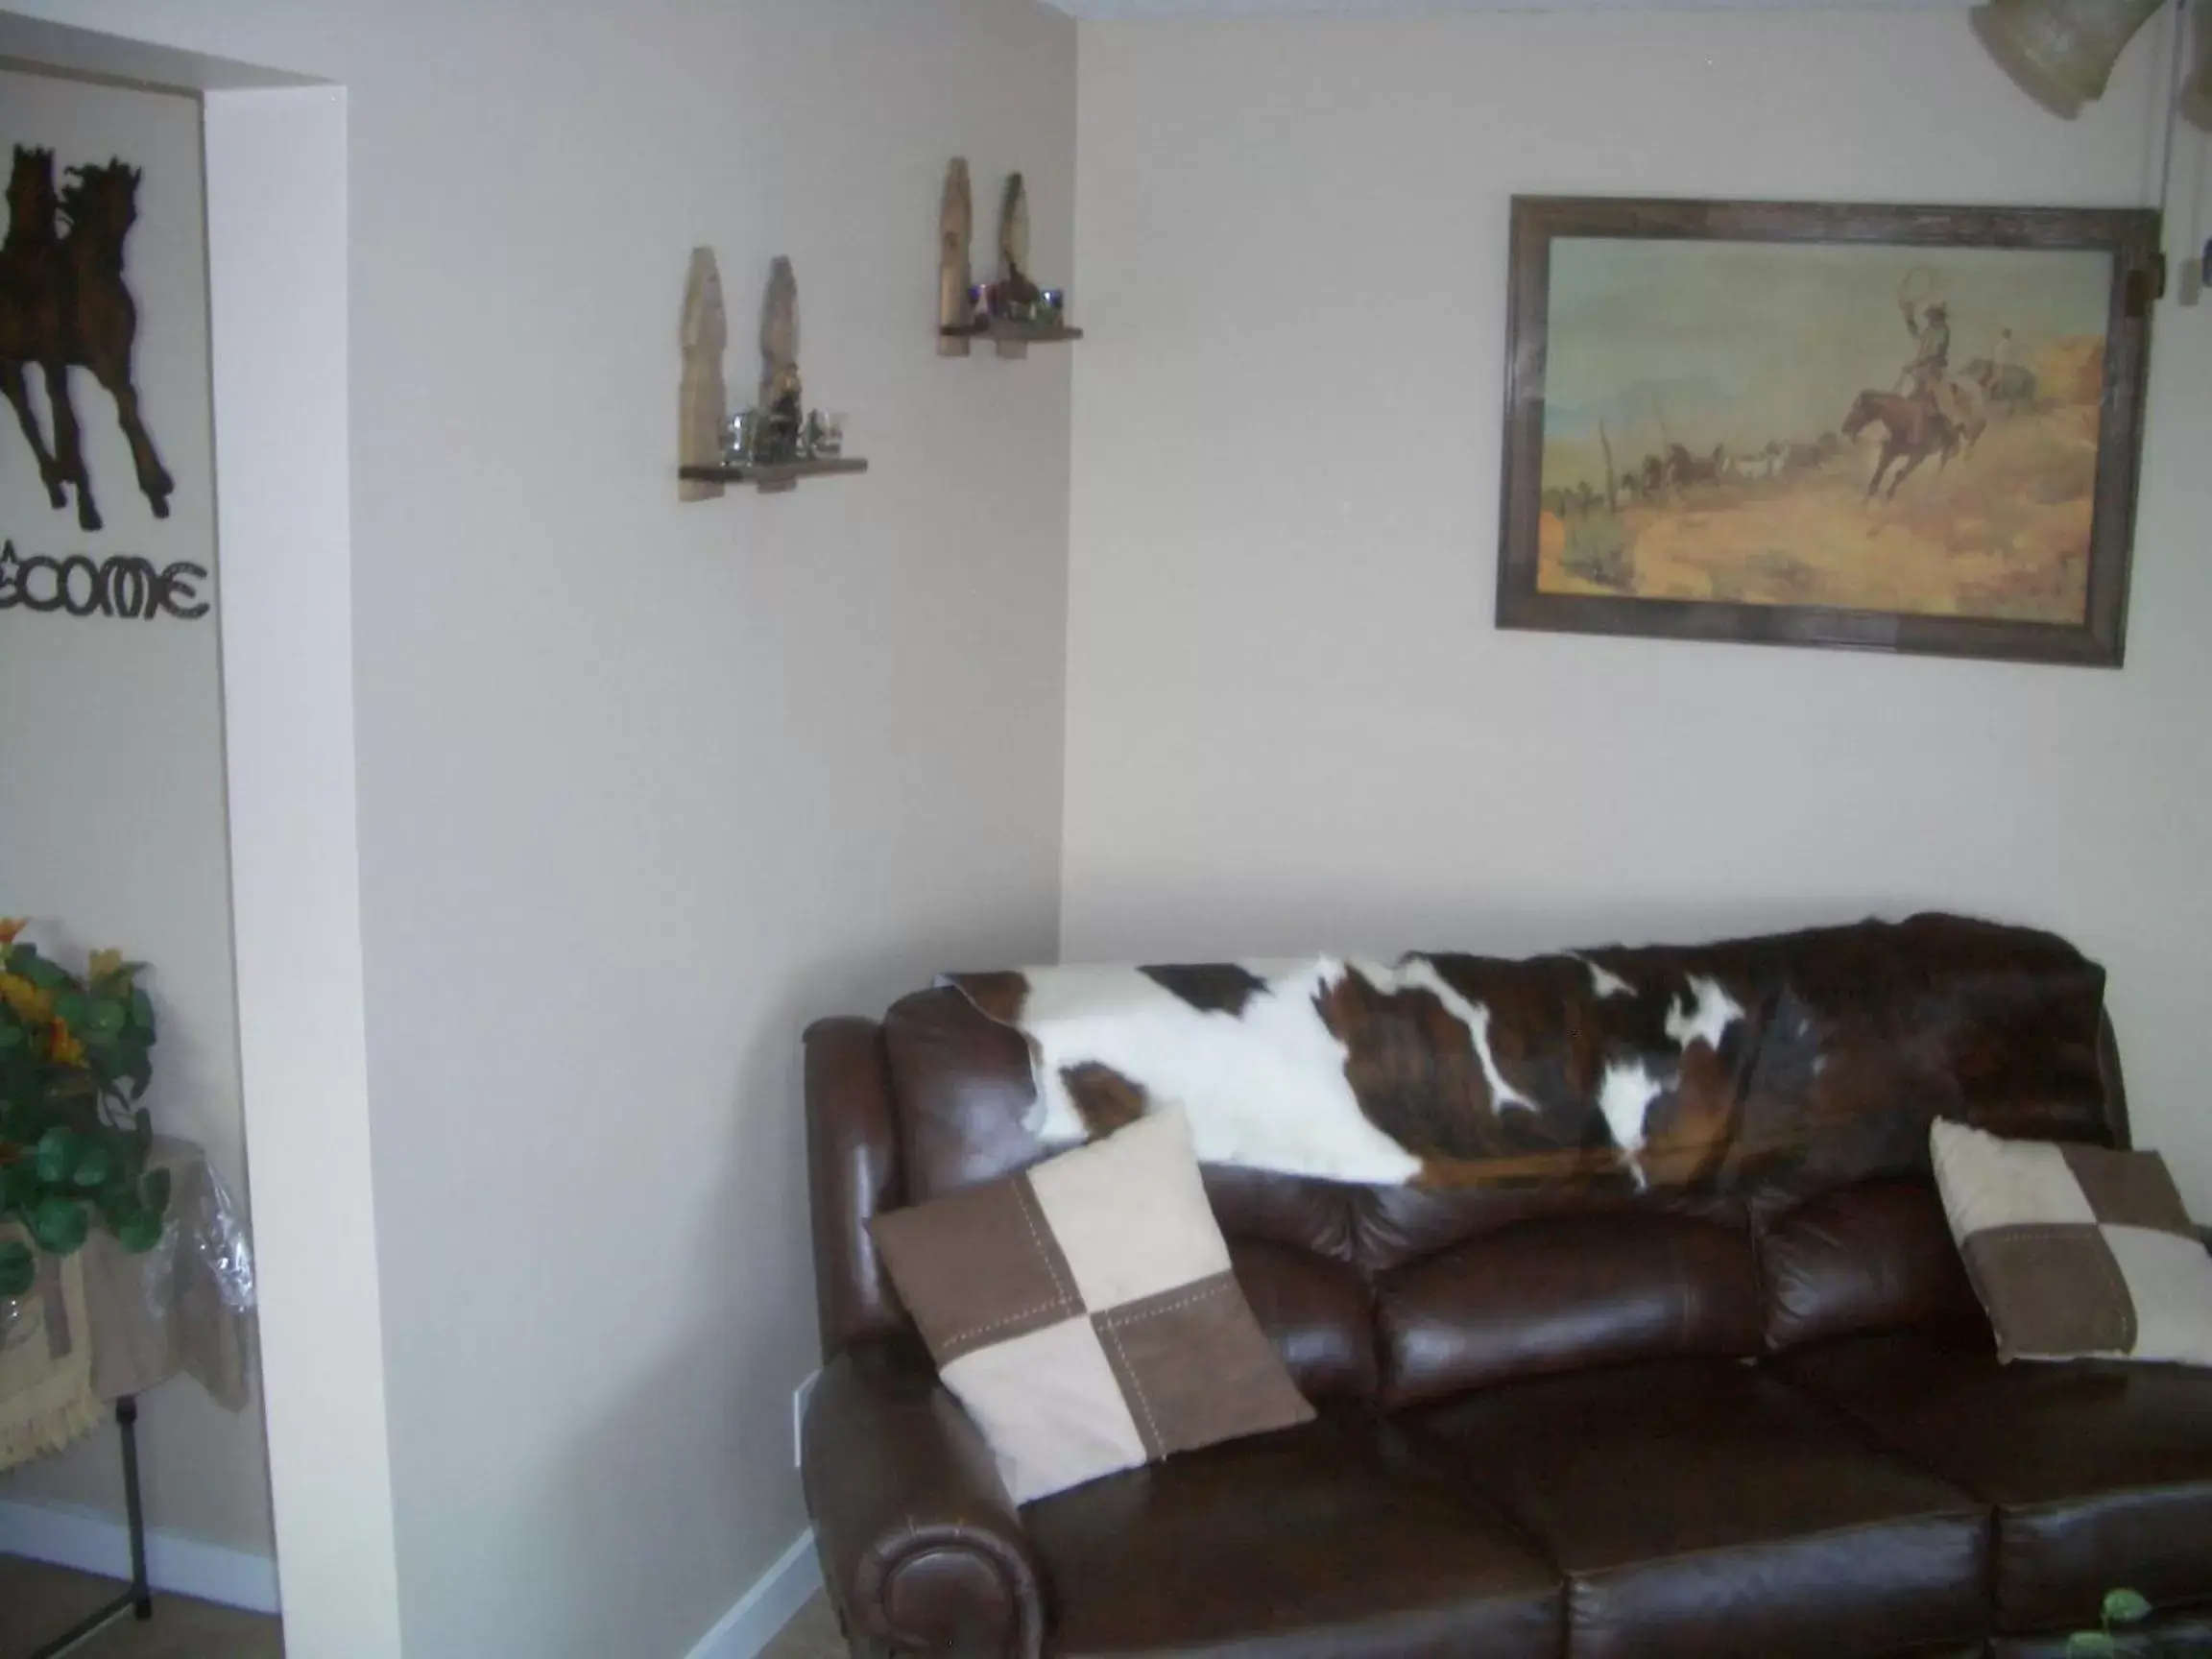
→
(1931, 1119, 2212, 1365)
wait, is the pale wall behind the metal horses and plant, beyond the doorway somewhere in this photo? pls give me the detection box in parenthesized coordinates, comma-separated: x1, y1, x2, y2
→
(0, 73, 270, 1552)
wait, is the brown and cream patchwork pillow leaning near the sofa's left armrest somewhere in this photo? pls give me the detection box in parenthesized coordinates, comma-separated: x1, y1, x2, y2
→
(869, 1111, 1314, 1504)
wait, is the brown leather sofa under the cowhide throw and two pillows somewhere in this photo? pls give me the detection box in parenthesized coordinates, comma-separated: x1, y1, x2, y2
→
(805, 942, 2212, 1659)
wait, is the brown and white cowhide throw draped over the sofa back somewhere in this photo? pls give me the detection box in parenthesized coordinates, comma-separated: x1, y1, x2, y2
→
(947, 916, 2104, 1188)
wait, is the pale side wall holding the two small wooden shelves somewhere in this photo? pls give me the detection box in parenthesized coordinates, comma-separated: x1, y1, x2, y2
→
(2, 0, 1075, 1659)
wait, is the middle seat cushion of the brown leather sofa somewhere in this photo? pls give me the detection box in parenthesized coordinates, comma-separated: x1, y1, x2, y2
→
(1403, 1360, 1988, 1659)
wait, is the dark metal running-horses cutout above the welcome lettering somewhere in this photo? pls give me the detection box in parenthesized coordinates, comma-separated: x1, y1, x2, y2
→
(0, 144, 175, 531)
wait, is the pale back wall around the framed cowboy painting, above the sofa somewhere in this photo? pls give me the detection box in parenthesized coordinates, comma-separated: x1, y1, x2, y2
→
(1062, 19, 2212, 1213)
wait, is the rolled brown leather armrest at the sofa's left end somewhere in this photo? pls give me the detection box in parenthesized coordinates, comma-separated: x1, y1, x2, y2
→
(803, 1338, 1044, 1659)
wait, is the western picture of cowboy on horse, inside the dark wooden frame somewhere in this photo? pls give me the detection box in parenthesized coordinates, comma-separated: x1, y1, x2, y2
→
(1508, 217, 2115, 626)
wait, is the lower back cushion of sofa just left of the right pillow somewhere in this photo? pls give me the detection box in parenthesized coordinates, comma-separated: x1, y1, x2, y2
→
(1759, 1179, 1982, 1349)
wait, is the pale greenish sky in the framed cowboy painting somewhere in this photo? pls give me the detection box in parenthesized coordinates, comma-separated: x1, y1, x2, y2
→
(1544, 237, 2112, 453)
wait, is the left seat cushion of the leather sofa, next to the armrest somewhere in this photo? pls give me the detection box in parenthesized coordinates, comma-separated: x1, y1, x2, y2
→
(1022, 1413, 1562, 1659)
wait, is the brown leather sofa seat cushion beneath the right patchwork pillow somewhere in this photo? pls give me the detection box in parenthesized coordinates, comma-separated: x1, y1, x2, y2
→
(1778, 1332, 2212, 1632)
